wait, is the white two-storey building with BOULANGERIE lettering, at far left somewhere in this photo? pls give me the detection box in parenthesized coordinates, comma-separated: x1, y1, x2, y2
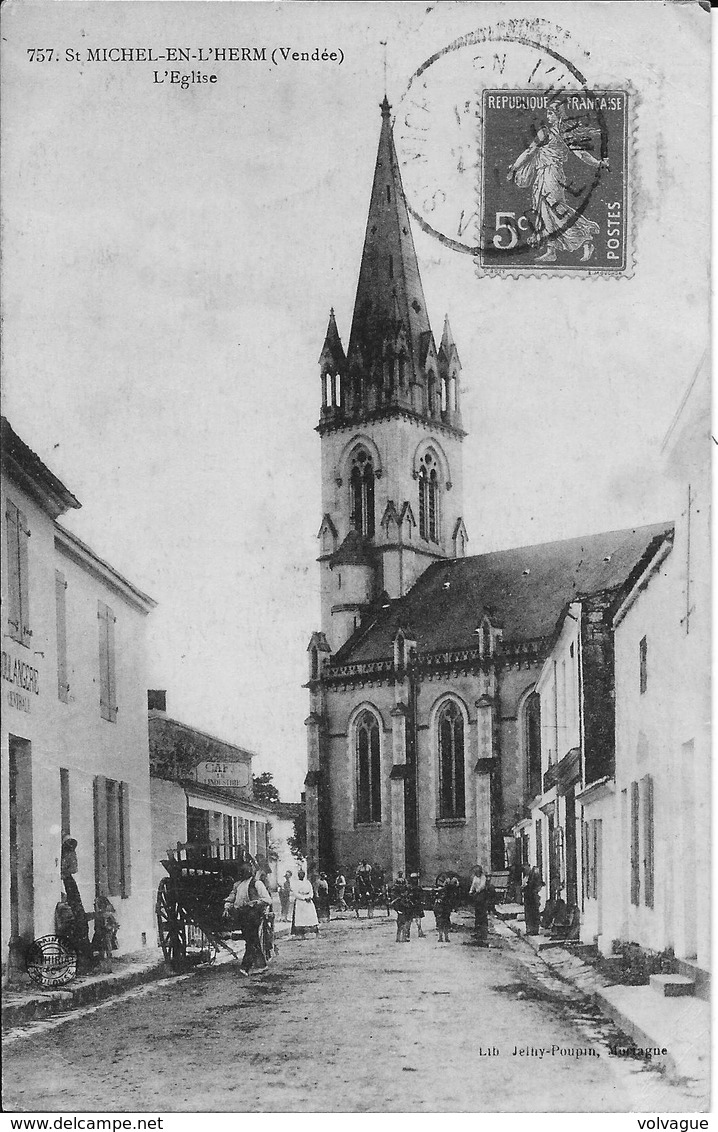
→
(1, 420, 155, 967)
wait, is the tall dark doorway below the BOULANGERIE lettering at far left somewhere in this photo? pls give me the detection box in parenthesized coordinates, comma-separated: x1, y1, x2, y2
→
(8, 735, 35, 943)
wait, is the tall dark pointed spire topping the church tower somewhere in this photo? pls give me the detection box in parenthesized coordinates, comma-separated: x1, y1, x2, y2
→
(347, 95, 433, 402)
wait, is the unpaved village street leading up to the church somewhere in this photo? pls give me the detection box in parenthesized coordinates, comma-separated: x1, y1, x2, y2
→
(3, 914, 699, 1113)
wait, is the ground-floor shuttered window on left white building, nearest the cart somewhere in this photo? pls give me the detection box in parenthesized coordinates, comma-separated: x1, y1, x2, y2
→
(93, 774, 131, 897)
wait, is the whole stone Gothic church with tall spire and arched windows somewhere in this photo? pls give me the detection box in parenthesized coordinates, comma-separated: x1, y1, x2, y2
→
(305, 97, 657, 882)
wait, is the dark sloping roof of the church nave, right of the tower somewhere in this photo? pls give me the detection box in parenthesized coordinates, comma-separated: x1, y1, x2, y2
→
(334, 523, 673, 664)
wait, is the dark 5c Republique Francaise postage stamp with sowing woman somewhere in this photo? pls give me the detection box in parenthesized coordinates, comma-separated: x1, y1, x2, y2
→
(477, 87, 631, 275)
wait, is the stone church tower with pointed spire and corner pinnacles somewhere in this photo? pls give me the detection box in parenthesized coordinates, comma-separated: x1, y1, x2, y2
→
(317, 96, 468, 652)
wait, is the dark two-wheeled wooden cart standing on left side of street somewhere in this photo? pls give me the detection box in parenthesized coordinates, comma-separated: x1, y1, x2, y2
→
(155, 842, 276, 971)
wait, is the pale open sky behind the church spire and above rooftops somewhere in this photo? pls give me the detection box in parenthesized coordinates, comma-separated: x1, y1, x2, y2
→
(0, 0, 710, 800)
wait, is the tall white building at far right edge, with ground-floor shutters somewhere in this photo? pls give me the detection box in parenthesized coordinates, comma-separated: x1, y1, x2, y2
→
(609, 361, 711, 986)
